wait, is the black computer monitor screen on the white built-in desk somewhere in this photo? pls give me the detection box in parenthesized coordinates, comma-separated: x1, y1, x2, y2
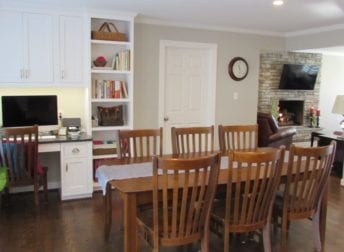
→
(1, 95, 58, 128)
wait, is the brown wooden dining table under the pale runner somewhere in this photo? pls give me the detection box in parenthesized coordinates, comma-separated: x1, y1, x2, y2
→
(96, 152, 327, 251)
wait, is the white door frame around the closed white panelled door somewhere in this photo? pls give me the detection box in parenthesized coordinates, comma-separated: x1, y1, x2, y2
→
(158, 40, 217, 127)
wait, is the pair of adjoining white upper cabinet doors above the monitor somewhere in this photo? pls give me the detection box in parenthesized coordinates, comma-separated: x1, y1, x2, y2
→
(0, 10, 54, 83)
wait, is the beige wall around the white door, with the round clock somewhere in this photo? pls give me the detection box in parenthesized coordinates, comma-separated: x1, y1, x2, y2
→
(134, 24, 285, 128)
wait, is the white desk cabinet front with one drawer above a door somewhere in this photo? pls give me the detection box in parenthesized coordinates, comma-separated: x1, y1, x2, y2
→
(60, 141, 93, 200)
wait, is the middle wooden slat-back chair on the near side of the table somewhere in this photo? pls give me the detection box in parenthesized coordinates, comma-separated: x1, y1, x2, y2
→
(210, 146, 285, 252)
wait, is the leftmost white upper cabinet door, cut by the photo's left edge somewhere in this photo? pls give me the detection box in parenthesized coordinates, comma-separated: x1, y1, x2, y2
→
(0, 10, 25, 83)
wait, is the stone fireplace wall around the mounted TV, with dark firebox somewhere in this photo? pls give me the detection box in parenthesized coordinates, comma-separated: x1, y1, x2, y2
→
(258, 51, 322, 141)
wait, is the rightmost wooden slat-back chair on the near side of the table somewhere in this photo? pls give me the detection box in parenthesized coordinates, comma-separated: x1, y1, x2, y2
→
(273, 141, 336, 251)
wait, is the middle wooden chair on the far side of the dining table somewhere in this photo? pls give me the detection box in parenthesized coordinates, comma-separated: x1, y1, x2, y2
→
(171, 125, 214, 154)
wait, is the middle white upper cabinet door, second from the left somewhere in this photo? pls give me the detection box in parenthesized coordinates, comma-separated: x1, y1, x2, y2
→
(23, 13, 54, 83)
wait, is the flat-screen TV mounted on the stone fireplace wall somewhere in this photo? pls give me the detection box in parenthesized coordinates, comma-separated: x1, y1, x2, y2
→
(279, 64, 319, 90)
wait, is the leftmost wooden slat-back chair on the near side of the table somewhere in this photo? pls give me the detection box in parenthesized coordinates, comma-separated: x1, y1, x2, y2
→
(137, 153, 221, 251)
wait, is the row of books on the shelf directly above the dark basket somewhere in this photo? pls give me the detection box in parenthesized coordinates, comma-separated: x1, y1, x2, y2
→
(91, 79, 128, 99)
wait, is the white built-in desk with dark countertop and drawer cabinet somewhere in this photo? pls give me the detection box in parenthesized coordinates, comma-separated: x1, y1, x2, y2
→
(38, 135, 93, 200)
